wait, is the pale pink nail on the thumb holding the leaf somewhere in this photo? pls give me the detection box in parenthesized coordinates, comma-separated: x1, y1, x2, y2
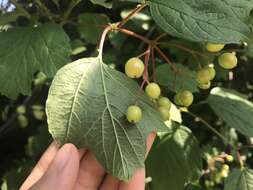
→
(53, 144, 74, 170)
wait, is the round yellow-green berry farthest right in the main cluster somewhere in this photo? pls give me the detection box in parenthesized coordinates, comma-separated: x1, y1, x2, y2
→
(218, 53, 238, 69)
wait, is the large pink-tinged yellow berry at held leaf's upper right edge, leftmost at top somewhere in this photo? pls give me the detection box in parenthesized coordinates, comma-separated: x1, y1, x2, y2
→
(125, 57, 144, 78)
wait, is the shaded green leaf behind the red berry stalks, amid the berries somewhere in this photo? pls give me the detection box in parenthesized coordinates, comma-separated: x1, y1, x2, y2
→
(157, 64, 199, 92)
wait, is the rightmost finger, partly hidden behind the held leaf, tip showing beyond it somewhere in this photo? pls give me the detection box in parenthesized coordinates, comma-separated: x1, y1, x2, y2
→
(119, 133, 156, 190)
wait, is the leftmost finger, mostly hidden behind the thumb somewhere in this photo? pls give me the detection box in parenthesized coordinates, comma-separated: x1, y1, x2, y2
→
(20, 142, 59, 190)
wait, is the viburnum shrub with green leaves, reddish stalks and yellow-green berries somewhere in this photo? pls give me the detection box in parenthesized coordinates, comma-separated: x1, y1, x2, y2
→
(0, 0, 253, 190)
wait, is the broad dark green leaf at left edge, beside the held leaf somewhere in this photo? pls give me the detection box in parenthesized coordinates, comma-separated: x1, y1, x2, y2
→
(0, 24, 71, 99)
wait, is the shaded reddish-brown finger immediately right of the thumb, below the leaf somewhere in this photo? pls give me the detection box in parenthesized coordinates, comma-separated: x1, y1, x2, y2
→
(74, 152, 105, 190)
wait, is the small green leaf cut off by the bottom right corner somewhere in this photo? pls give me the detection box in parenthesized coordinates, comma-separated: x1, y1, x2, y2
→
(224, 168, 253, 190)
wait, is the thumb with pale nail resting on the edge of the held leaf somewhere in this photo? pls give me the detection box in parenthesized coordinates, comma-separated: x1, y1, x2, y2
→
(30, 144, 79, 190)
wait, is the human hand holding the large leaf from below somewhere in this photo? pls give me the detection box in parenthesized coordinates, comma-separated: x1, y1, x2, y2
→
(20, 134, 155, 190)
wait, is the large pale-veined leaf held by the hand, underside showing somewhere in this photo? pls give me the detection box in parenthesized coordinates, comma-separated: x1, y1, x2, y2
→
(46, 58, 168, 180)
